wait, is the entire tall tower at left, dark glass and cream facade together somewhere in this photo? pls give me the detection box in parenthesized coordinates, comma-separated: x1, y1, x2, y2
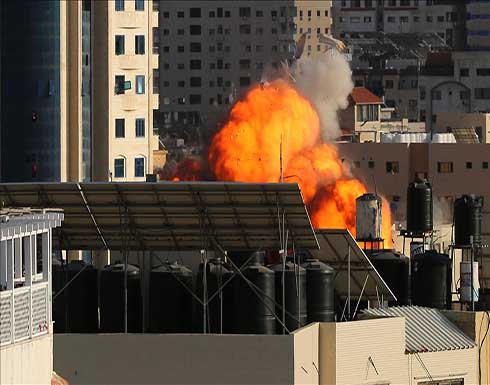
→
(0, 0, 158, 182)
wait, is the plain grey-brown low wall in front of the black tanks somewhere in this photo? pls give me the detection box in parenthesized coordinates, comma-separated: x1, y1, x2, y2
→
(54, 334, 294, 385)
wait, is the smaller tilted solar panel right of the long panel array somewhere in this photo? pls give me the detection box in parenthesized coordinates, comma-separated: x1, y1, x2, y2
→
(310, 229, 396, 302)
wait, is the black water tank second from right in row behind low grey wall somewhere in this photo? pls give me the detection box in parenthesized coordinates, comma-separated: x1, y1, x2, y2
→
(271, 261, 307, 334)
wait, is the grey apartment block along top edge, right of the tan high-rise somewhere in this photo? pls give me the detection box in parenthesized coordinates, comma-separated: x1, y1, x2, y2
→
(333, 0, 465, 48)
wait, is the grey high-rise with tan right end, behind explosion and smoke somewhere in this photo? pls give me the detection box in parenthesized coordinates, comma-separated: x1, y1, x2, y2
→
(158, 0, 332, 136)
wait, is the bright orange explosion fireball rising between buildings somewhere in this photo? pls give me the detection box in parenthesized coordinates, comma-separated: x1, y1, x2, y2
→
(208, 79, 391, 243)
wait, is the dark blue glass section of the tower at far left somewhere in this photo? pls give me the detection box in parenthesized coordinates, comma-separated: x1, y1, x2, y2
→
(0, 0, 61, 182)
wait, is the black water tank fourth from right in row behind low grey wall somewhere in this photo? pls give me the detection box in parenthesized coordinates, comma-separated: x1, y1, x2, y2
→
(194, 258, 233, 333)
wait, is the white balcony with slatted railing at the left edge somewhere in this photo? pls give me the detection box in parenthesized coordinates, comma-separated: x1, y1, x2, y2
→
(0, 211, 63, 347)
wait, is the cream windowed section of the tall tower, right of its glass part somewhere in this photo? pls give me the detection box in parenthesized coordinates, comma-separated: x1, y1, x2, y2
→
(93, 0, 159, 181)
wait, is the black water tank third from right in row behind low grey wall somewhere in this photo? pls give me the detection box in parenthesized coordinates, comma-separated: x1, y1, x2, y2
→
(233, 262, 276, 334)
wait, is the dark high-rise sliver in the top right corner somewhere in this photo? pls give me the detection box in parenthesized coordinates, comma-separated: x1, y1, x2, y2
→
(466, 0, 490, 50)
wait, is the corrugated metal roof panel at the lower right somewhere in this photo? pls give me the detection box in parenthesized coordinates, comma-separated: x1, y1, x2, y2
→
(364, 306, 475, 353)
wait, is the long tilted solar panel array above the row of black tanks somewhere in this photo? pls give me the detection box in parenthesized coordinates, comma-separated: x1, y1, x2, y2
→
(0, 182, 318, 250)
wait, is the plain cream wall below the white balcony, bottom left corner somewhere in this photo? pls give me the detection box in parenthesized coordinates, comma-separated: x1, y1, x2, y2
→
(0, 334, 53, 385)
